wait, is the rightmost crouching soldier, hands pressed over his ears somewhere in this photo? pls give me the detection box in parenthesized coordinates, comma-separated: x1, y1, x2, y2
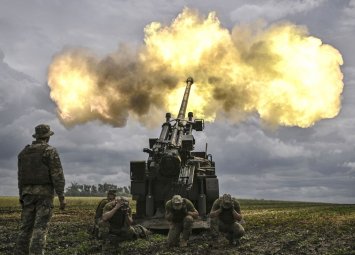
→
(210, 194, 245, 246)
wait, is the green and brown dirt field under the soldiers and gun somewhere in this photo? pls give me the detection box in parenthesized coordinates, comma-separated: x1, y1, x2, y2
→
(0, 197, 355, 255)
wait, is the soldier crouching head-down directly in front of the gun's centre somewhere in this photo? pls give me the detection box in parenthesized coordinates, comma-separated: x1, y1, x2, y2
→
(165, 195, 198, 247)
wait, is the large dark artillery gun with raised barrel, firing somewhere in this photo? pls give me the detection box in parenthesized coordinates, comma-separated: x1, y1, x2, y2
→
(130, 77, 219, 229)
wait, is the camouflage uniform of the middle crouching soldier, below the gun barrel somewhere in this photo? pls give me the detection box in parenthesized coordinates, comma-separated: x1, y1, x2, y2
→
(165, 196, 196, 246)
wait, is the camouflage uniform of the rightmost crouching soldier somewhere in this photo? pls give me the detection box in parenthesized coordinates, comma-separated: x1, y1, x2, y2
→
(211, 197, 245, 243)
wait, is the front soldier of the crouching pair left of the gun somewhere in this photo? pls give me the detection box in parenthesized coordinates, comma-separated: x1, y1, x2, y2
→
(102, 197, 137, 254)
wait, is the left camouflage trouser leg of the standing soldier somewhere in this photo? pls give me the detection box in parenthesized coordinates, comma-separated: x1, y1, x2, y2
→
(14, 204, 36, 255)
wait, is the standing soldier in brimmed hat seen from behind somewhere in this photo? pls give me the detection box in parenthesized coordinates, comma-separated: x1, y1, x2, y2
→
(15, 124, 66, 255)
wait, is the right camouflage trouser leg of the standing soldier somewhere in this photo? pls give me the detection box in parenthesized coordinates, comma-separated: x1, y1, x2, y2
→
(30, 199, 53, 255)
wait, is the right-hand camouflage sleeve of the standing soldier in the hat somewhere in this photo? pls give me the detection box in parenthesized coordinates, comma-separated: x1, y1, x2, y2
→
(48, 147, 65, 197)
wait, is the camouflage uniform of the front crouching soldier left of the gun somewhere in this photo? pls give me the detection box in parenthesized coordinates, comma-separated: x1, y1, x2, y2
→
(100, 201, 137, 255)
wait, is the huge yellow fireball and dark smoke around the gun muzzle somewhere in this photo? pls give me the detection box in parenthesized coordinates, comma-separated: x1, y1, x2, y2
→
(48, 9, 343, 128)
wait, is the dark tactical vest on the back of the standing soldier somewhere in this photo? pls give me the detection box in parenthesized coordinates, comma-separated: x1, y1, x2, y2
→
(19, 144, 52, 185)
